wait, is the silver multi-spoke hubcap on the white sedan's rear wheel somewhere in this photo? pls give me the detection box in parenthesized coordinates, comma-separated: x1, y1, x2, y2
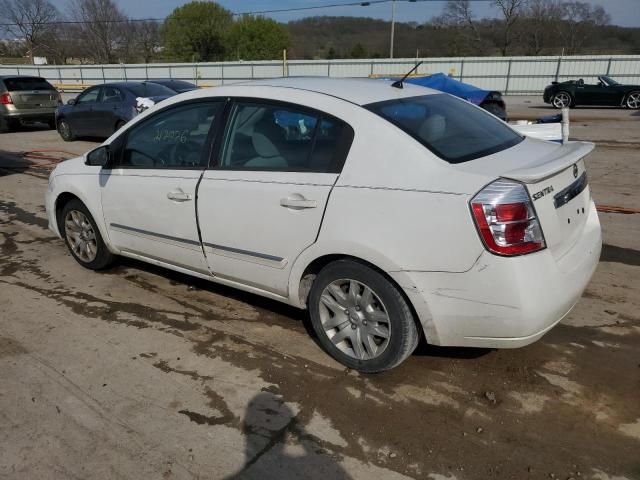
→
(320, 279, 391, 360)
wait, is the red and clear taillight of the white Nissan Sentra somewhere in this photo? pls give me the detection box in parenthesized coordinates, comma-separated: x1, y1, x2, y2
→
(471, 180, 545, 256)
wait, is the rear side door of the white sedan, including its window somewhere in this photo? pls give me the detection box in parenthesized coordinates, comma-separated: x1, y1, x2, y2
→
(198, 100, 353, 295)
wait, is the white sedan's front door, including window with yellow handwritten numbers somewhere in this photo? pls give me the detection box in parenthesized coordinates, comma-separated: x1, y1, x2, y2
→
(100, 100, 222, 273)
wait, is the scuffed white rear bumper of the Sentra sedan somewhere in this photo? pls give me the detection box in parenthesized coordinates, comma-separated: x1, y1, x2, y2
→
(391, 202, 602, 348)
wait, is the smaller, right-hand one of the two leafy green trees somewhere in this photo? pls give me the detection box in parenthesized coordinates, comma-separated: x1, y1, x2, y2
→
(225, 15, 290, 60)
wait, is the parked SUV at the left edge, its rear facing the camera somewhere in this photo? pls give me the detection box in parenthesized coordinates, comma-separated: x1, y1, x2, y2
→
(0, 75, 61, 131)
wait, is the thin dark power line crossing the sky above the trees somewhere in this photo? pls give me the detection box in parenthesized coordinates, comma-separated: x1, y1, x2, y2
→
(0, 0, 491, 27)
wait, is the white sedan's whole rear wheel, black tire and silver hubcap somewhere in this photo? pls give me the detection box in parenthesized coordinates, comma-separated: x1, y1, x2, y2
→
(309, 260, 420, 373)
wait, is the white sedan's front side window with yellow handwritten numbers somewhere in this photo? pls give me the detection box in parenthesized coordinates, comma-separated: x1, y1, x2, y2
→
(119, 101, 222, 168)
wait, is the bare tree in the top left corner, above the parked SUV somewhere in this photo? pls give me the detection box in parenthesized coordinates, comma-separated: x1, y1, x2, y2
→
(0, 0, 60, 63)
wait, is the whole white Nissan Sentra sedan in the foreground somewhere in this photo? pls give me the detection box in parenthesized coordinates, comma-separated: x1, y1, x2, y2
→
(46, 78, 601, 372)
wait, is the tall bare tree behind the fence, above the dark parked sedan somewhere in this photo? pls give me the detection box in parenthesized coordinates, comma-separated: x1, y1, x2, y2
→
(69, 0, 127, 63)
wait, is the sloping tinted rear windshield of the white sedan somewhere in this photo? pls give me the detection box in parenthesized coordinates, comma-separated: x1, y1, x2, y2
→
(366, 94, 523, 163)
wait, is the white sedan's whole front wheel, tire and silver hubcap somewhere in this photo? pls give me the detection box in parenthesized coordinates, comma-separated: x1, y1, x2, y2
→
(58, 199, 115, 270)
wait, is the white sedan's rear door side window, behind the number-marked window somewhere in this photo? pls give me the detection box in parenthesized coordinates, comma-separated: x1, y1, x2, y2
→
(218, 101, 353, 172)
